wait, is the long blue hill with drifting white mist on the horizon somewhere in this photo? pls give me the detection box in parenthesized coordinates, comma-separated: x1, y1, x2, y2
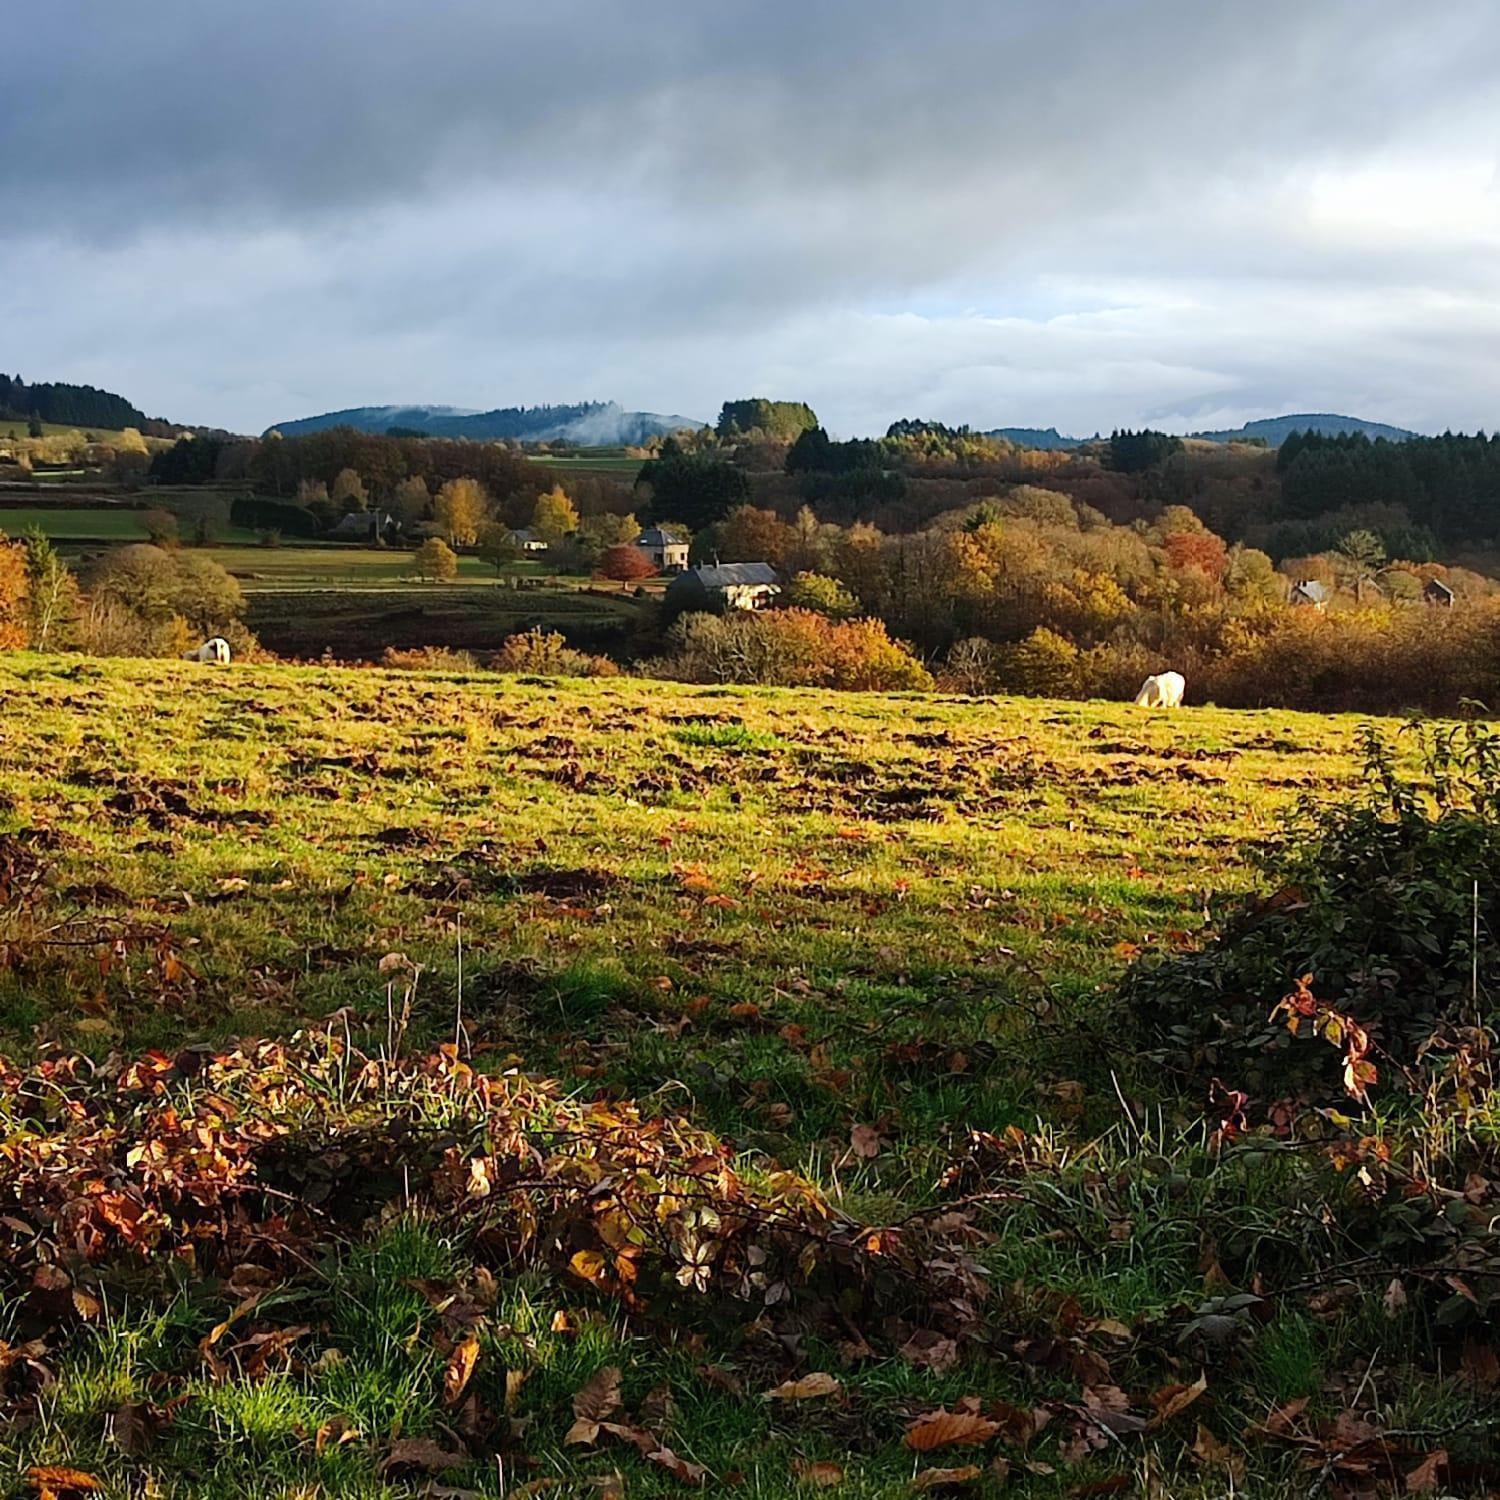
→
(267, 401, 708, 447)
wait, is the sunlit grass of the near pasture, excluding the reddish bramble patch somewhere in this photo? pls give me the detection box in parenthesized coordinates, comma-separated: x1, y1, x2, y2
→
(0, 654, 1473, 1497)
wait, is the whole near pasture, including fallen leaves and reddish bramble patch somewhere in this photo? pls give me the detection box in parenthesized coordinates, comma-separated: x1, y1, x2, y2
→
(0, 654, 1500, 1497)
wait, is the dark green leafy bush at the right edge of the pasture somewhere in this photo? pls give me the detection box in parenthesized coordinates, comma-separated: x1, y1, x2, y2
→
(1125, 723, 1500, 1100)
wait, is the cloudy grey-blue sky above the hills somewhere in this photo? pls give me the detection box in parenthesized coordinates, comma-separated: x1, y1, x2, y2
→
(0, 0, 1500, 437)
